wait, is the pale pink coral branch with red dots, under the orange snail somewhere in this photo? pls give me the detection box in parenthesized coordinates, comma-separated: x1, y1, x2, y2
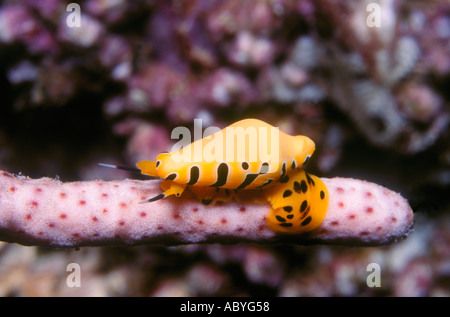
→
(0, 171, 413, 247)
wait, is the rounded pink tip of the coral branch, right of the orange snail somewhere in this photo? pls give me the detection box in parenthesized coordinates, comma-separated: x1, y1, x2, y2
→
(318, 178, 413, 243)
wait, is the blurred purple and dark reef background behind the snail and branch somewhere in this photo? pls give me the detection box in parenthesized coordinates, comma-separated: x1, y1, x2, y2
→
(0, 0, 450, 296)
